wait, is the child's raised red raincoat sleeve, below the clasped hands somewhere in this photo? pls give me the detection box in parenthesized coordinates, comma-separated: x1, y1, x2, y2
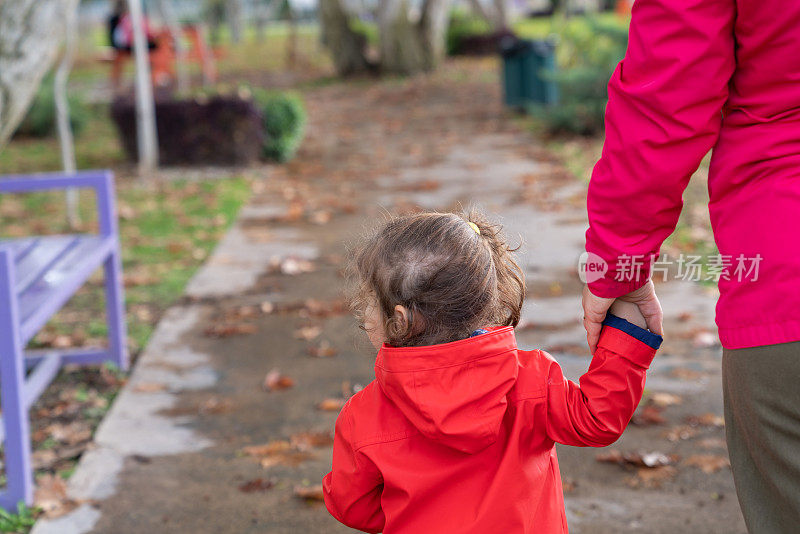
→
(547, 327, 656, 447)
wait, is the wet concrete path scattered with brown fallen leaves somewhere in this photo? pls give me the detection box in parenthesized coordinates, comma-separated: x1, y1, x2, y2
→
(34, 63, 744, 534)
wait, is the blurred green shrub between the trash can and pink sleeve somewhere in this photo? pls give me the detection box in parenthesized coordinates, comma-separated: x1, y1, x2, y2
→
(529, 19, 628, 135)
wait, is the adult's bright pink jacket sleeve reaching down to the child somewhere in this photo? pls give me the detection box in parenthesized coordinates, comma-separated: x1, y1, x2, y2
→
(586, 0, 736, 297)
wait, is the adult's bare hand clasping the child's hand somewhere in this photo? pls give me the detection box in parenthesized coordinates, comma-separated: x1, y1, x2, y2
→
(583, 280, 664, 354)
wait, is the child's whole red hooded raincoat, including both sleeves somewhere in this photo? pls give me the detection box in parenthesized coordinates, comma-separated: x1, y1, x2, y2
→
(323, 327, 655, 534)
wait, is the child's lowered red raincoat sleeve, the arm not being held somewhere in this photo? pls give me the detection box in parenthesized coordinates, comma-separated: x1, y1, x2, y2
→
(322, 405, 386, 532)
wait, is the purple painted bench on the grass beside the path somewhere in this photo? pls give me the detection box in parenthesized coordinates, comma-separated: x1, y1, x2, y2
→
(0, 171, 128, 510)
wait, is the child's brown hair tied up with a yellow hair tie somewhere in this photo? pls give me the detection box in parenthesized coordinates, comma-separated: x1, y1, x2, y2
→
(352, 209, 525, 347)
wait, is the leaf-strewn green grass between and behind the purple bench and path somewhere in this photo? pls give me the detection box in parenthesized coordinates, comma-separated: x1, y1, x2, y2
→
(0, 177, 250, 358)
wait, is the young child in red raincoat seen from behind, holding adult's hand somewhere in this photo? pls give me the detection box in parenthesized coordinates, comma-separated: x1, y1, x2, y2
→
(323, 212, 661, 534)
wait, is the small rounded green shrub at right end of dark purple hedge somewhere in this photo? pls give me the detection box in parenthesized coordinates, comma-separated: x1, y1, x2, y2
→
(255, 91, 306, 162)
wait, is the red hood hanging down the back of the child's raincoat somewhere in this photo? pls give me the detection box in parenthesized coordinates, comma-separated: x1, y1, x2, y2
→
(375, 326, 519, 454)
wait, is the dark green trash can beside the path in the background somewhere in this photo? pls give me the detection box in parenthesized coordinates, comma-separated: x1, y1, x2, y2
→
(500, 39, 558, 108)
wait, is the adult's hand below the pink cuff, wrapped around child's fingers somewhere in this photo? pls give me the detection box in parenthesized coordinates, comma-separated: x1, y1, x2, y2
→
(583, 280, 664, 354)
